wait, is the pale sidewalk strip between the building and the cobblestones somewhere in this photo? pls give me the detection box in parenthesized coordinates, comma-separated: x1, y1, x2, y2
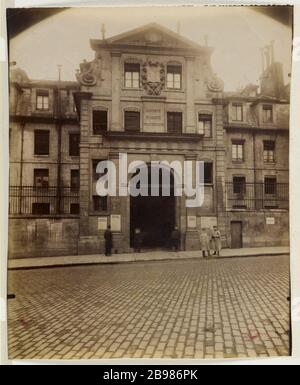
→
(8, 247, 290, 270)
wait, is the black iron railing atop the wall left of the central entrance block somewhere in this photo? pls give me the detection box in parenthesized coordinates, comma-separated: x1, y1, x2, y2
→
(9, 186, 79, 216)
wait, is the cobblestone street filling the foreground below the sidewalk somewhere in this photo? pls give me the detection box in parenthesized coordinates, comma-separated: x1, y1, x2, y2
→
(9, 256, 289, 359)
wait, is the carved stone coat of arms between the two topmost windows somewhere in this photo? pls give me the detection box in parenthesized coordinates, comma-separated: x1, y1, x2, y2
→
(141, 61, 166, 96)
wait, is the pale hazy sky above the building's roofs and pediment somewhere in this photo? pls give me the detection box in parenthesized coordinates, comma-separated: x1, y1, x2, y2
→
(10, 6, 292, 91)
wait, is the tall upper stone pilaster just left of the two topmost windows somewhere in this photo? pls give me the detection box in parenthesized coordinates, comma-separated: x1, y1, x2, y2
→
(111, 52, 122, 131)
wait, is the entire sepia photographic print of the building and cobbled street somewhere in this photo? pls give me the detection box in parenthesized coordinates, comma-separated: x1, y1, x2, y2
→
(7, 6, 293, 360)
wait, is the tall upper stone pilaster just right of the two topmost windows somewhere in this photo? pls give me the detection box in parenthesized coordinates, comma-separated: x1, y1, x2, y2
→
(186, 57, 196, 134)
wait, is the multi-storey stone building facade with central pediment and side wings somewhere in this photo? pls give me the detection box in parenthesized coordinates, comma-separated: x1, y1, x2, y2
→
(9, 24, 289, 258)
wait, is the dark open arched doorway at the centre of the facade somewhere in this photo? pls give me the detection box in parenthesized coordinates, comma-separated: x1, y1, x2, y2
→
(130, 166, 176, 249)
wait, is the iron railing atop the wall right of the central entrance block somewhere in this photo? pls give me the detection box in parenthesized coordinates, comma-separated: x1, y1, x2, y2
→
(225, 182, 289, 210)
